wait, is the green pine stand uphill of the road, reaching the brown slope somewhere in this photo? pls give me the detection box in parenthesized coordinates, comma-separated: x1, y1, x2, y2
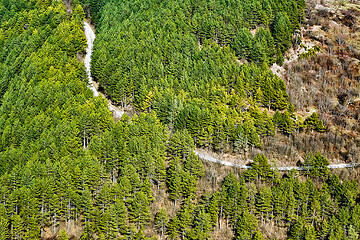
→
(85, 0, 304, 154)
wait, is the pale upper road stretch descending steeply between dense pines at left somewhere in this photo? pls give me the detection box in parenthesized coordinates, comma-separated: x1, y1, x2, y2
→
(84, 21, 124, 119)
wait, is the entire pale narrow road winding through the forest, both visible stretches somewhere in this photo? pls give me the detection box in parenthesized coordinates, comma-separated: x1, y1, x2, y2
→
(84, 21, 360, 171)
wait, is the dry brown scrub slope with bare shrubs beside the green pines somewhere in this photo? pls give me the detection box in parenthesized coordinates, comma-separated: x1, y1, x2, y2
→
(263, 1, 360, 164)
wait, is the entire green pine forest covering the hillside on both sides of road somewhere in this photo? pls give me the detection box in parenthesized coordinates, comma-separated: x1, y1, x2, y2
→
(0, 0, 360, 240)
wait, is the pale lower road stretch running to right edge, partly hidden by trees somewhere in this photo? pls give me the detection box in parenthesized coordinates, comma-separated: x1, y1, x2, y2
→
(194, 150, 360, 171)
